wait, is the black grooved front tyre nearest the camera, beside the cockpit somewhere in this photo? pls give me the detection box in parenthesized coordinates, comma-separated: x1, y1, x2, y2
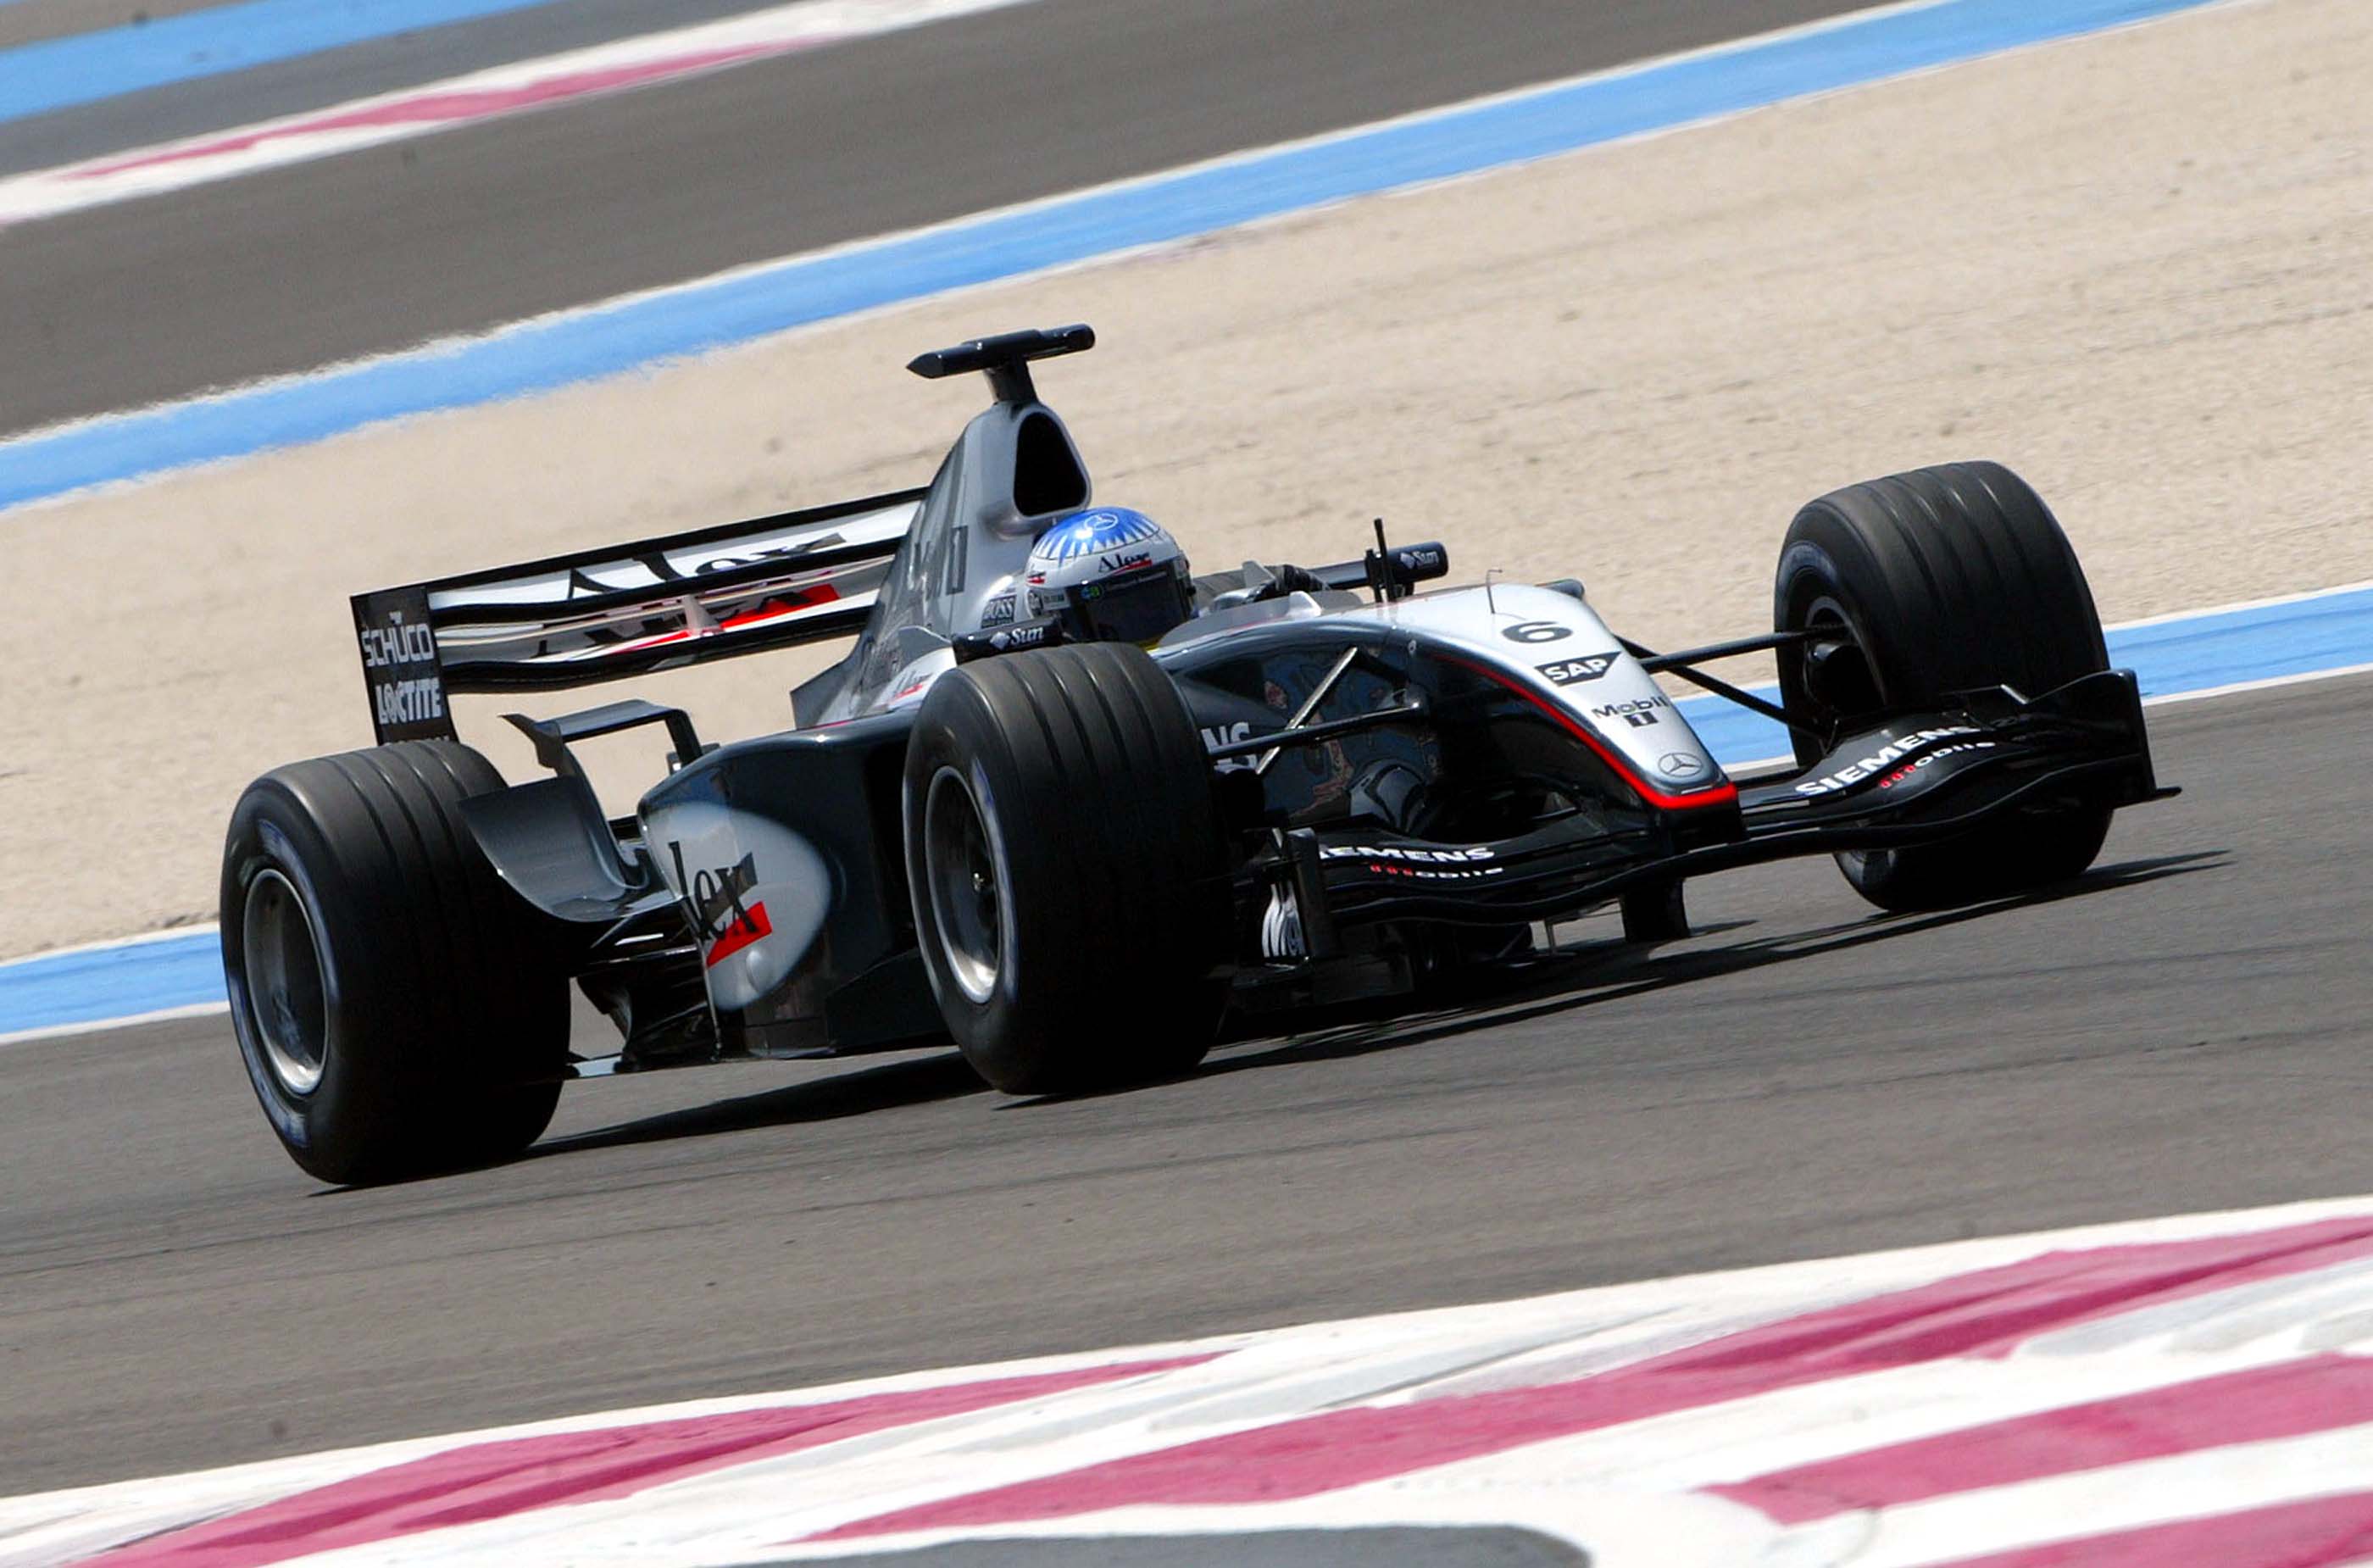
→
(904, 642, 1231, 1093)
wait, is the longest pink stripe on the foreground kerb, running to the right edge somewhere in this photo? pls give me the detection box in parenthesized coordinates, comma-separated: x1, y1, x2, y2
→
(816, 1217, 2373, 1539)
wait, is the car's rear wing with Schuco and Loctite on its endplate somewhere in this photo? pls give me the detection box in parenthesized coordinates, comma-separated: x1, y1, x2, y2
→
(353, 489, 923, 745)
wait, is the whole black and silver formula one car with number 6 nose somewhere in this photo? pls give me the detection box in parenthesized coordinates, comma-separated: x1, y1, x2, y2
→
(223, 327, 2171, 1182)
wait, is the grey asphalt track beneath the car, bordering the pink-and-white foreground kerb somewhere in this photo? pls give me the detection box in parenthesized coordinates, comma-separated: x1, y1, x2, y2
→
(0, 676, 2373, 1494)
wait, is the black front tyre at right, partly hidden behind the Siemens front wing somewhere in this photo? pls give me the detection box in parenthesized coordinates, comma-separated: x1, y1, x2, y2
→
(1773, 463, 2109, 909)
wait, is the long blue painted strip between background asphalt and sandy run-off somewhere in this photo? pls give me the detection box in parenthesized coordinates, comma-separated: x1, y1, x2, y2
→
(0, 0, 2209, 508)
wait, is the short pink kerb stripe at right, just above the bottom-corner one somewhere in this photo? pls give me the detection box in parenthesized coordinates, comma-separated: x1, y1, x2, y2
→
(1706, 1354, 2373, 1518)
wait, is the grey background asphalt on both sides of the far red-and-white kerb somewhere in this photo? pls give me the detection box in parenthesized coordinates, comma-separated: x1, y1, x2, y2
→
(0, 0, 1860, 434)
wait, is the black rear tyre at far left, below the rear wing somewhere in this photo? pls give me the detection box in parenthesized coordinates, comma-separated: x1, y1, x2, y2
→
(223, 740, 570, 1184)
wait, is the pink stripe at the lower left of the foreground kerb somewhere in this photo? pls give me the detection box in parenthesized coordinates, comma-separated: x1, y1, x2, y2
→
(95, 1354, 1217, 1568)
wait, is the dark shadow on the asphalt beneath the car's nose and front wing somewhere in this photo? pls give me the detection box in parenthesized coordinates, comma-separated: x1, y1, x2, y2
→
(1203, 849, 2228, 1075)
